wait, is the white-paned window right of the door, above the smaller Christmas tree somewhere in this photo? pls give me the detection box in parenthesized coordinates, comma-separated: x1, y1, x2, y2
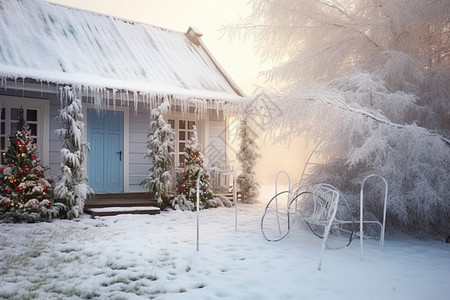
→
(168, 118, 197, 168)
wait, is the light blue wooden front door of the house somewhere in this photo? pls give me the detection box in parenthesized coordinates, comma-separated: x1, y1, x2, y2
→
(87, 109, 124, 193)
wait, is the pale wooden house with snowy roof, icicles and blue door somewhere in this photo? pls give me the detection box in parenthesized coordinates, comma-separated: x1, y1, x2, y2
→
(0, 0, 243, 194)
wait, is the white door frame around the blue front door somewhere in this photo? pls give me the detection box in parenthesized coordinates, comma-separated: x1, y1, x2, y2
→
(83, 103, 130, 193)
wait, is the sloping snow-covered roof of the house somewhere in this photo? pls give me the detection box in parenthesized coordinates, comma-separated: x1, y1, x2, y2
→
(0, 0, 242, 100)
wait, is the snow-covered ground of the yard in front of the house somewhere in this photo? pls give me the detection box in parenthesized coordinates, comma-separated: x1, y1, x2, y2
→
(0, 186, 450, 300)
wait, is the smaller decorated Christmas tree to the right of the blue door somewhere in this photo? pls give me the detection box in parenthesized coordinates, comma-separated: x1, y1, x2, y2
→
(173, 126, 214, 210)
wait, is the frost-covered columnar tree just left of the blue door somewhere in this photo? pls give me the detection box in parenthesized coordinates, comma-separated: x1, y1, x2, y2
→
(55, 87, 93, 219)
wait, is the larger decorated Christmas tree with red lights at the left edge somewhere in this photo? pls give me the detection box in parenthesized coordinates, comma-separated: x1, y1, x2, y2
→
(0, 109, 58, 221)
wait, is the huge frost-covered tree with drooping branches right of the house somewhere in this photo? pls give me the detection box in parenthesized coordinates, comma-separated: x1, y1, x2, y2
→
(234, 0, 450, 235)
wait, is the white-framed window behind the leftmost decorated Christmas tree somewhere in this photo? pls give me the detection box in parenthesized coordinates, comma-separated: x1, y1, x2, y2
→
(0, 96, 48, 164)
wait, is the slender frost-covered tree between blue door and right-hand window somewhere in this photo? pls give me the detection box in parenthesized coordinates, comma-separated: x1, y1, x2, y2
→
(141, 102, 175, 206)
